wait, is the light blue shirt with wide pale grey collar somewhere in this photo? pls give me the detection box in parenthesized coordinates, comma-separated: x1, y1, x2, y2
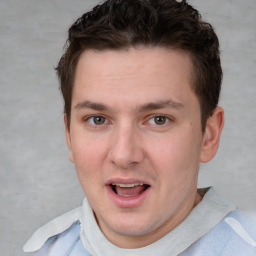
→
(24, 188, 256, 256)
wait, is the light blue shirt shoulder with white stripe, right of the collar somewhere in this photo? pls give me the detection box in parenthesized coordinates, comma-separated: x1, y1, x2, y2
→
(185, 210, 256, 256)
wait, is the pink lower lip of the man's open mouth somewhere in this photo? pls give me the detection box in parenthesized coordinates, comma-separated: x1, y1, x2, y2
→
(106, 185, 151, 208)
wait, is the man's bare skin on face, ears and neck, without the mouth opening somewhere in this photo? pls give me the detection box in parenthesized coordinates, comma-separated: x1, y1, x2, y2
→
(65, 47, 223, 248)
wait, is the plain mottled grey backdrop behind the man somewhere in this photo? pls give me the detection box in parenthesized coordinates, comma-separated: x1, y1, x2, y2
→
(0, 0, 256, 255)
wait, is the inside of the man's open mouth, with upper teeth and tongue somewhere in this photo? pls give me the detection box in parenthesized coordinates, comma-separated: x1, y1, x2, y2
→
(110, 183, 150, 197)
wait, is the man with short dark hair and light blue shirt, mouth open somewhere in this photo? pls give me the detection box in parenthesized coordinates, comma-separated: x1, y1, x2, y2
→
(24, 0, 256, 256)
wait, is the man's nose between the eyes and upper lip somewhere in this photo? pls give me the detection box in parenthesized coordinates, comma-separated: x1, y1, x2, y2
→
(109, 125, 144, 170)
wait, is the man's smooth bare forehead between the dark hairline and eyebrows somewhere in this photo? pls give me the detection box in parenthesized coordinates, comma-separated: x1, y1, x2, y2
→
(72, 47, 198, 108)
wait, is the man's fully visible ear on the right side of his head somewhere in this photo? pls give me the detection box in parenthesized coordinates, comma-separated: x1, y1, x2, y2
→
(200, 107, 224, 163)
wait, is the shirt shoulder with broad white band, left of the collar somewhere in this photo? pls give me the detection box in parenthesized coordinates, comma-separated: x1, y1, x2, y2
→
(23, 207, 81, 255)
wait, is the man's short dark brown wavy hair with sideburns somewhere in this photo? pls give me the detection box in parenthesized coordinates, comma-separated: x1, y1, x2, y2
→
(56, 0, 222, 131)
